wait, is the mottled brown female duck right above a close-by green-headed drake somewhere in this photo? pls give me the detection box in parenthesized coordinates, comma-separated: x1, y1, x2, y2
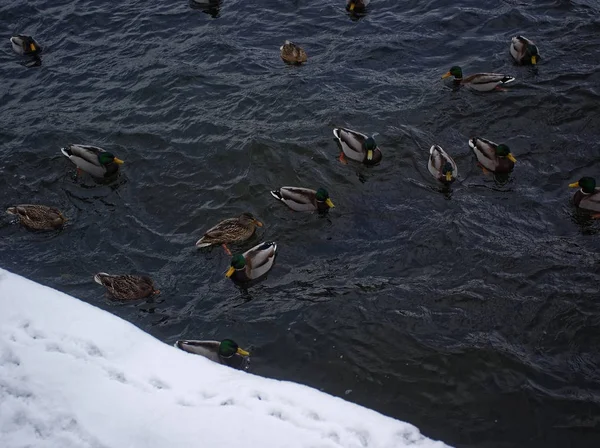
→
(196, 212, 263, 256)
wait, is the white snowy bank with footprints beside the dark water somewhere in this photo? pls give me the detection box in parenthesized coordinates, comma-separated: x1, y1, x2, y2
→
(0, 269, 447, 448)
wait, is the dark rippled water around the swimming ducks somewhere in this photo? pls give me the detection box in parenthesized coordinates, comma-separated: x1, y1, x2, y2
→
(0, 0, 600, 447)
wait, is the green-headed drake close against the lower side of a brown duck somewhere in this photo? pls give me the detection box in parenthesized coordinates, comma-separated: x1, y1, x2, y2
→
(225, 243, 277, 283)
